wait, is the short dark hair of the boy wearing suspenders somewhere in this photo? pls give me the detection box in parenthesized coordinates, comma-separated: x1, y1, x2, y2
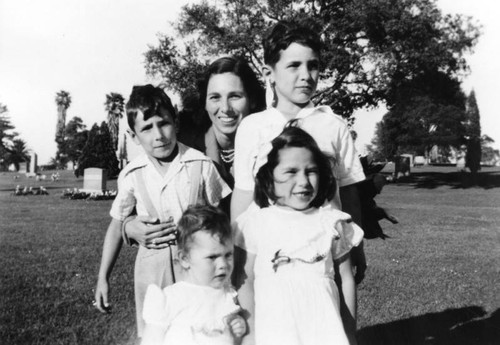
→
(125, 84, 176, 132)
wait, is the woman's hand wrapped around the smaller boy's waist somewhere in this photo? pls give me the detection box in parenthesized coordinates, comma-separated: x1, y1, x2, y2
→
(125, 216, 177, 249)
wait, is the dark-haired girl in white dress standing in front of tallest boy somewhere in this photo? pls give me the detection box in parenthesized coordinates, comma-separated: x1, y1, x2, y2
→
(236, 126, 363, 345)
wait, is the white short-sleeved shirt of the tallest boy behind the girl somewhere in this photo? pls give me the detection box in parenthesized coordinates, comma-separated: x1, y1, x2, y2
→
(234, 104, 365, 209)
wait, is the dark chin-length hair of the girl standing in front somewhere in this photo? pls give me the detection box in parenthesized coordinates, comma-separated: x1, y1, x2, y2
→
(254, 121, 337, 208)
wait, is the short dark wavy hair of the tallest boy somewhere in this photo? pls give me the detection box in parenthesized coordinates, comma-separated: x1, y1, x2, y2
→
(262, 21, 321, 66)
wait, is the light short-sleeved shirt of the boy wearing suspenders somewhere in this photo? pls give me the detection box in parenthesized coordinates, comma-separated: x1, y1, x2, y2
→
(110, 143, 231, 222)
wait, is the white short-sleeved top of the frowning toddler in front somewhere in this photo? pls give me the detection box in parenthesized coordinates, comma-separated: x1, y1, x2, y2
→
(143, 281, 240, 345)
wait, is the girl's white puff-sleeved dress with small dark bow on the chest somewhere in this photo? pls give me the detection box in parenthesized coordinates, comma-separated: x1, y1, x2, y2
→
(236, 206, 363, 345)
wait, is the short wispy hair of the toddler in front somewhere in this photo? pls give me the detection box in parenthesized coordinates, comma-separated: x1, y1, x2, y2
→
(177, 205, 232, 251)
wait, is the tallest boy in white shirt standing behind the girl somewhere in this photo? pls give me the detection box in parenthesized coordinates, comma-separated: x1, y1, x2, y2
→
(231, 22, 366, 283)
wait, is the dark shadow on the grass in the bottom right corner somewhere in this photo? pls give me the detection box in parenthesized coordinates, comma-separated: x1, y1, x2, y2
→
(357, 306, 500, 345)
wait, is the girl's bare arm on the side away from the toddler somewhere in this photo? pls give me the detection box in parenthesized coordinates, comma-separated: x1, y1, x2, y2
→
(335, 254, 357, 345)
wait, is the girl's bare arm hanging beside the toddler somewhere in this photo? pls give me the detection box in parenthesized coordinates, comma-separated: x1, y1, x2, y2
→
(236, 247, 255, 345)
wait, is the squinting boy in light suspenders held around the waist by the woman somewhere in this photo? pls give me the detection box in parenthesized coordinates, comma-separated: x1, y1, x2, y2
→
(95, 85, 231, 337)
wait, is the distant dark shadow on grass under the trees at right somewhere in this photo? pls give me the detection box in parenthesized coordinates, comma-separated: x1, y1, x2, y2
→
(388, 171, 500, 189)
